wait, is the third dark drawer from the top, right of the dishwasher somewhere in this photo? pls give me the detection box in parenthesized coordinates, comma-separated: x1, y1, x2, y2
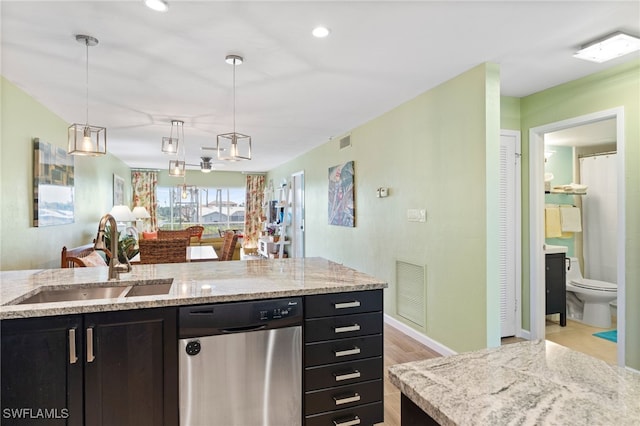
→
(304, 334, 382, 367)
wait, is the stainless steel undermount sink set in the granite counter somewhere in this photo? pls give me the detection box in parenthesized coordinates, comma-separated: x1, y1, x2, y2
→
(14, 278, 173, 305)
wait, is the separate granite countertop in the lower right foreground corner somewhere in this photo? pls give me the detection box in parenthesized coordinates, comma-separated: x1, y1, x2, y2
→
(389, 340, 640, 426)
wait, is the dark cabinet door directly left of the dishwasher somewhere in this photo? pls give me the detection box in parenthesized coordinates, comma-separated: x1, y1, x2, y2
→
(84, 308, 178, 426)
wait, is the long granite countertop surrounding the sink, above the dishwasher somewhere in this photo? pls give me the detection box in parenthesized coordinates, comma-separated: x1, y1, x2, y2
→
(0, 258, 387, 319)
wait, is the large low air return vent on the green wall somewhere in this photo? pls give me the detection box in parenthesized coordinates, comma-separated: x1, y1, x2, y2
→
(396, 260, 427, 328)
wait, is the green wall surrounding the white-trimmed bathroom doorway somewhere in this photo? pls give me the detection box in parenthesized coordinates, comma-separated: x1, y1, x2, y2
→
(521, 60, 640, 369)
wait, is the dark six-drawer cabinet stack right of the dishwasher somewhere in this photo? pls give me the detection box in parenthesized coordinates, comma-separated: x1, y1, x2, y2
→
(303, 290, 384, 426)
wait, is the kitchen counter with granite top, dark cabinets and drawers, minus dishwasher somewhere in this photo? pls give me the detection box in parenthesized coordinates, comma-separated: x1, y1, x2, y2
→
(0, 258, 387, 426)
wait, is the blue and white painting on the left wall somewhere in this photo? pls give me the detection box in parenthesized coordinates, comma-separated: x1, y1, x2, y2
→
(33, 138, 74, 227)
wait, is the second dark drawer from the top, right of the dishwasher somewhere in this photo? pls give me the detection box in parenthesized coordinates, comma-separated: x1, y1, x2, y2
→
(304, 312, 382, 342)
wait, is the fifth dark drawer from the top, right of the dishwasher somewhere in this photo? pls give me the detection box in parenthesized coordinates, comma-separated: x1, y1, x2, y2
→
(304, 379, 383, 415)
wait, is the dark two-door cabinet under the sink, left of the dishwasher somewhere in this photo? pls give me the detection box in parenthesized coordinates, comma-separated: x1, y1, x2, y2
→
(2, 308, 178, 426)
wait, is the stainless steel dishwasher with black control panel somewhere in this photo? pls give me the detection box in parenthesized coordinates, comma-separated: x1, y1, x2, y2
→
(178, 297, 303, 426)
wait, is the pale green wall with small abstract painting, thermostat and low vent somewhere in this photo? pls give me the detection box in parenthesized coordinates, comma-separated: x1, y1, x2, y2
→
(268, 64, 500, 352)
